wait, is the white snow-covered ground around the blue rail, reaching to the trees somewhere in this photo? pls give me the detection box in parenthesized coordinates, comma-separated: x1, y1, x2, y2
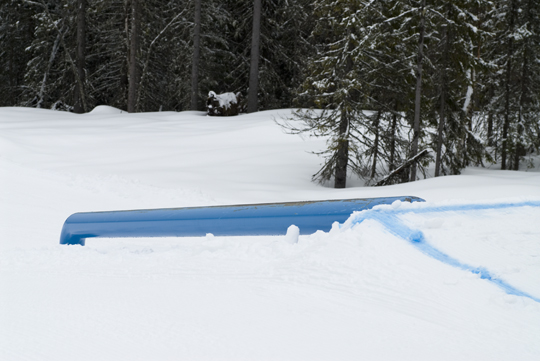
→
(0, 106, 540, 361)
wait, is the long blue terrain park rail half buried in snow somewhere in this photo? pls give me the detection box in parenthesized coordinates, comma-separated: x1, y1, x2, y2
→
(60, 196, 424, 246)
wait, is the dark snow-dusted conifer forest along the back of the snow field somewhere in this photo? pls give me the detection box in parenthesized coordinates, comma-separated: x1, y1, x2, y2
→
(0, 0, 540, 188)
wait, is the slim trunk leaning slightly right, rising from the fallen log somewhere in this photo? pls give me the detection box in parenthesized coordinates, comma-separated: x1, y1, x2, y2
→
(410, 0, 426, 182)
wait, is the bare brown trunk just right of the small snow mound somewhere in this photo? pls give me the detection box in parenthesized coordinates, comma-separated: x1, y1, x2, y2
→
(127, 0, 141, 113)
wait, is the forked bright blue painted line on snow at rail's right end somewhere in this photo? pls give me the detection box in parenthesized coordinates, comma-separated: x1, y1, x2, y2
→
(354, 202, 540, 303)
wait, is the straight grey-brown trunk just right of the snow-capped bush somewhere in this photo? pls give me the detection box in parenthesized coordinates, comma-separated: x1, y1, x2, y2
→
(247, 0, 262, 113)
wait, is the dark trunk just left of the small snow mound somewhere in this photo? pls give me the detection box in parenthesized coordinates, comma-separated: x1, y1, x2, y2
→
(73, 0, 87, 114)
